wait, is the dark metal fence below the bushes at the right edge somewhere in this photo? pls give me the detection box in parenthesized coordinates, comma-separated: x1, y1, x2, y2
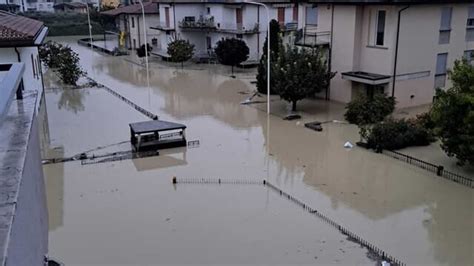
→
(382, 150, 474, 188)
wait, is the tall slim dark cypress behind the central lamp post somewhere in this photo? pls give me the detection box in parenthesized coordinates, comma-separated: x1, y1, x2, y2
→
(257, 19, 281, 94)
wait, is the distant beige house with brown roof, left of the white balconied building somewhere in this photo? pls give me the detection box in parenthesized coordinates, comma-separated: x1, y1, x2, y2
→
(102, 2, 160, 49)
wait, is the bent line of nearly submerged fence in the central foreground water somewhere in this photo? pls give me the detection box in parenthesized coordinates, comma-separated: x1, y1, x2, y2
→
(172, 177, 406, 265)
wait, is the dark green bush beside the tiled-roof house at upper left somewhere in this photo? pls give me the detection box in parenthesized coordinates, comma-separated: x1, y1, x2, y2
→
(39, 41, 86, 85)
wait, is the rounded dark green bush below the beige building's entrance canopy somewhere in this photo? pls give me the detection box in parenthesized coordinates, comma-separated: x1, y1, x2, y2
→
(344, 93, 396, 126)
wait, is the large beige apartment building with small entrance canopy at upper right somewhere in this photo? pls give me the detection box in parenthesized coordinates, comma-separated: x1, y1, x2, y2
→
(298, 0, 474, 108)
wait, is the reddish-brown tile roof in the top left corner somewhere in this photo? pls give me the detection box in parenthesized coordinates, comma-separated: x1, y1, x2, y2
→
(0, 11, 44, 46)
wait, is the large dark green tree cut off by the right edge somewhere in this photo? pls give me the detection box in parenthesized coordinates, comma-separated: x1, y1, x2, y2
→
(431, 60, 474, 165)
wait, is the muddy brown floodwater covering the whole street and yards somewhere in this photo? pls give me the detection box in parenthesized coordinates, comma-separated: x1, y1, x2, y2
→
(42, 38, 474, 265)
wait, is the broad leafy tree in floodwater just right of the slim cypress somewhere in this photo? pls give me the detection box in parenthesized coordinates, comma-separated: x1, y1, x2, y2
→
(272, 46, 335, 111)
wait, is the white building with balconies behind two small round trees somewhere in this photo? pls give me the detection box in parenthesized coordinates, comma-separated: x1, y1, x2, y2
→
(150, 0, 298, 61)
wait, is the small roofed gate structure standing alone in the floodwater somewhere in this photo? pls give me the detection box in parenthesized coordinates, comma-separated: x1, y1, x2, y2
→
(129, 120, 186, 151)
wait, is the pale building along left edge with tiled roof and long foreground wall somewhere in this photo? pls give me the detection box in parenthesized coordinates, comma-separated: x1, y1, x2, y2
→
(0, 11, 48, 266)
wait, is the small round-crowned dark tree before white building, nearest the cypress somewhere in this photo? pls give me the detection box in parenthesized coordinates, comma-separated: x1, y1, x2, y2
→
(214, 38, 249, 74)
